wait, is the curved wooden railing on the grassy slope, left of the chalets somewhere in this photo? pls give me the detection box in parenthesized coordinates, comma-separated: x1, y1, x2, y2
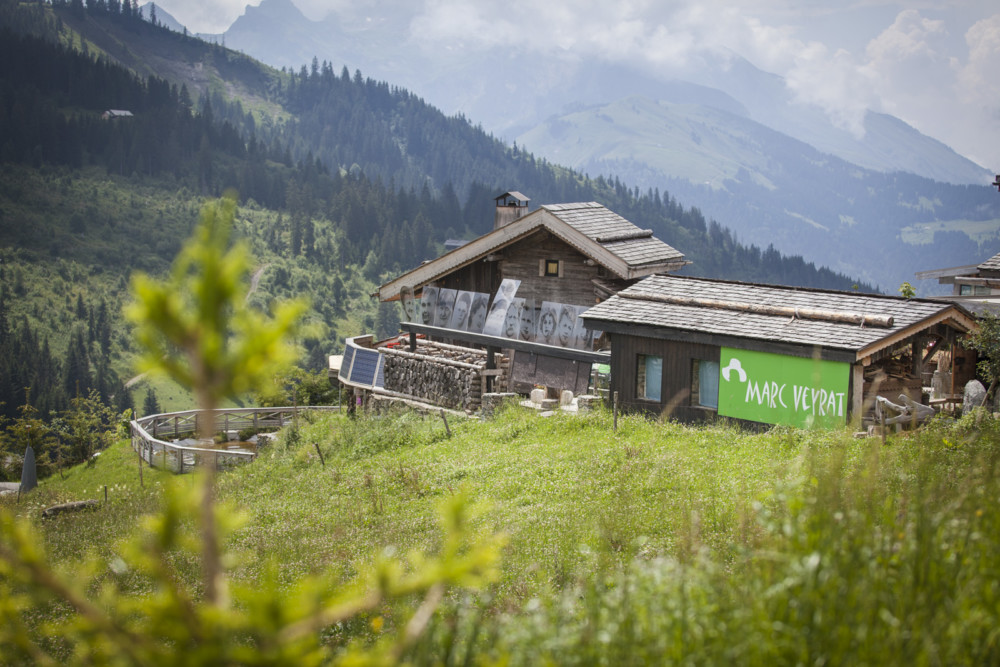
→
(130, 406, 340, 473)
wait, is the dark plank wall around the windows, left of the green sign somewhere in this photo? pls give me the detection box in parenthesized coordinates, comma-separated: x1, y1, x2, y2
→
(608, 334, 720, 422)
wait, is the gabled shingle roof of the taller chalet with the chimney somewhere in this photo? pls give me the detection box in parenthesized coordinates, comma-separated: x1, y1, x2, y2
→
(378, 202, 690, 301)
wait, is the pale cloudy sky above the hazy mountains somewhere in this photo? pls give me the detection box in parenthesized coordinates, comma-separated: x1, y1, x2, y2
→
(150, 0, 1000, 172)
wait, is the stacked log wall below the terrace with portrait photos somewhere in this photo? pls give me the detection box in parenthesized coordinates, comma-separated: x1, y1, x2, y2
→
(380, 341, 510, 412)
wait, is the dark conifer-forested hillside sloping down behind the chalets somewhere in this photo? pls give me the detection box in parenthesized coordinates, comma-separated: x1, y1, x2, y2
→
(0, 0, 865, 444)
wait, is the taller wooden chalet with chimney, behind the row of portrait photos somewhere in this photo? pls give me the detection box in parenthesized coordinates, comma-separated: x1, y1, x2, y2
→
(364, 191, 689, 402)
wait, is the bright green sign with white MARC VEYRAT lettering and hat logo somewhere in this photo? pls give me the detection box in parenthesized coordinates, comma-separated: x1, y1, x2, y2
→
(719, 347, 850, 428)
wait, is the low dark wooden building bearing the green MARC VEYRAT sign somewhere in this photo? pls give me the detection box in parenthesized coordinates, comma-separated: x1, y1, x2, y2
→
(581, 276, 976, 427)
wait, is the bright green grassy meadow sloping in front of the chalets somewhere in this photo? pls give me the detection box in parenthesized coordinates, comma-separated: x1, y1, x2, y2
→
(0, 409, 1000, 665)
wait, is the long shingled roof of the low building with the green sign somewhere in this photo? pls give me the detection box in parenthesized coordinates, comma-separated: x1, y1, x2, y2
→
(582, 276, 976, 360)
